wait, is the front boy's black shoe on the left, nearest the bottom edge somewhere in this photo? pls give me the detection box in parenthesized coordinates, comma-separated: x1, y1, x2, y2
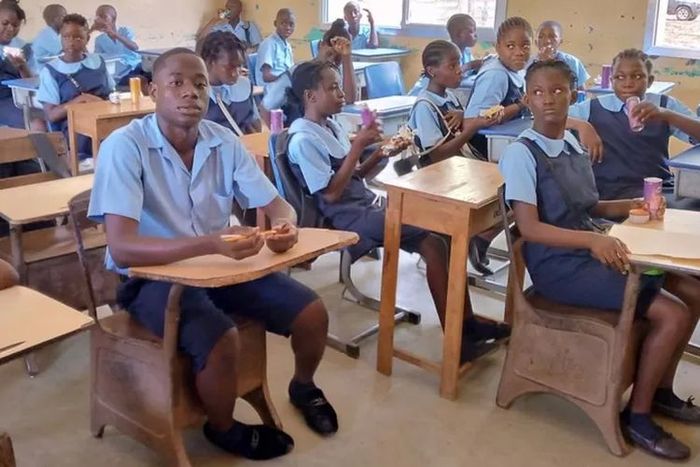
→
(202, 422, 294, 461)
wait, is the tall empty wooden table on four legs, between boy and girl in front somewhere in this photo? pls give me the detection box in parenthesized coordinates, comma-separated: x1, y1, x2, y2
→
(377, 157, 503, 399)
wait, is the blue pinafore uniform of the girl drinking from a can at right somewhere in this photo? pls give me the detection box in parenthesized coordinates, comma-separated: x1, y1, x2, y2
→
(569, 93, 693, 200)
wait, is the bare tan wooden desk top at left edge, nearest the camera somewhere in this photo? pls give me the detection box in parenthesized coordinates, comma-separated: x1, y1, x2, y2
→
(0, 286, 93, 363)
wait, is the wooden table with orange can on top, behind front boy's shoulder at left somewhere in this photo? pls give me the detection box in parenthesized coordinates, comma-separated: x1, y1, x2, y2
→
(66, 96, 156, 175)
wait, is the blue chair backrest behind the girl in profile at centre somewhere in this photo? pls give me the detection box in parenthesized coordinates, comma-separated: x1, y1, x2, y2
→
(269, 130, 323, 227)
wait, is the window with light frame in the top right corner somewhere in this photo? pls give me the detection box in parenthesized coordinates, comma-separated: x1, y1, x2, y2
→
(644, 0, 700, 58)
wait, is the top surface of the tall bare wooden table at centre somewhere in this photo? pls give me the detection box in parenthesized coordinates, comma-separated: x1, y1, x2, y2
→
(385, 157, 503, 208)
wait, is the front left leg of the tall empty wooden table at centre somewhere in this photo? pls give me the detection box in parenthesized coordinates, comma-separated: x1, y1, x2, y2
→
(377, 191, 403, 376)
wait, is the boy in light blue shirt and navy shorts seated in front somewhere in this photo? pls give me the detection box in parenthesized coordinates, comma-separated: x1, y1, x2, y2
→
(89, 48, 338, 459)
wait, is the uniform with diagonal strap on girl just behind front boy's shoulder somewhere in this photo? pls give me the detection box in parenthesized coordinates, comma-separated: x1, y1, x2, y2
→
(209, 76, 260, 133)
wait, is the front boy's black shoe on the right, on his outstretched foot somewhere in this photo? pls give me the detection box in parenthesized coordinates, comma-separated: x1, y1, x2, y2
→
(289, 381, 338, 436)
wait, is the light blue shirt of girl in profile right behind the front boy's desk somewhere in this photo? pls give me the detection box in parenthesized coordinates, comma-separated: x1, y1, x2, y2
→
(288, 118, 351, 194)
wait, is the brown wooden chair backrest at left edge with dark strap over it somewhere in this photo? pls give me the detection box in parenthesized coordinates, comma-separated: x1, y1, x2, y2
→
(0, 133, 68, 190)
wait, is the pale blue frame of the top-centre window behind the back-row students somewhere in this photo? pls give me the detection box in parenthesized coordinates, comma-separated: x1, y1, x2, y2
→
(319, 0, 506, 42)
